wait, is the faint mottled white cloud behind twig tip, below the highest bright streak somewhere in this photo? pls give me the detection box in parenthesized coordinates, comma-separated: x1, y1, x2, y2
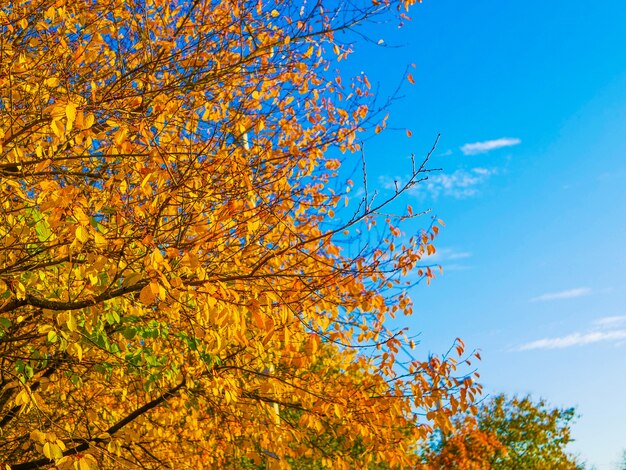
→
(379, 168, 497, 199)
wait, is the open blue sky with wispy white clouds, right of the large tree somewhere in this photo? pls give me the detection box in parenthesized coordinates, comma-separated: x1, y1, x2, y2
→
(336, 0, 626, 470)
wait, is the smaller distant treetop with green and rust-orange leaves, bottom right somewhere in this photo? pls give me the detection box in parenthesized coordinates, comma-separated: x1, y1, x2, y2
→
(425, 394, 584, 470)
